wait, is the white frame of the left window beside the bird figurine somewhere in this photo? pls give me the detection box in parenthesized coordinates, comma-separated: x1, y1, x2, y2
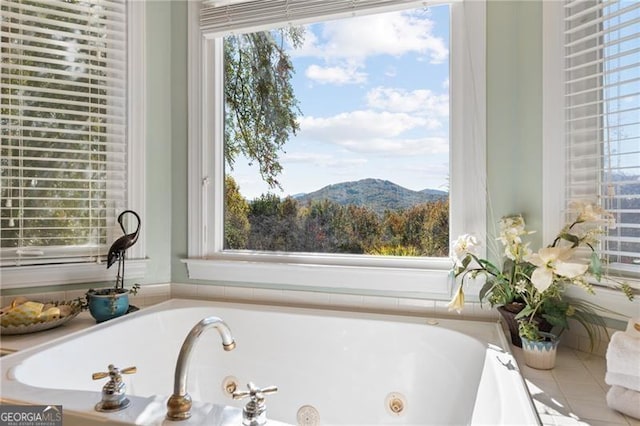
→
(0, 1, 146, 289)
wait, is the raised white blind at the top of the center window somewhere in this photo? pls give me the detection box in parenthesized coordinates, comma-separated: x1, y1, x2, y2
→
(200, 0, 438, 36)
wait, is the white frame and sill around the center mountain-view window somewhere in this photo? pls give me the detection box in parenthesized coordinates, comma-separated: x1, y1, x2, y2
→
(182, 0, 486, 298)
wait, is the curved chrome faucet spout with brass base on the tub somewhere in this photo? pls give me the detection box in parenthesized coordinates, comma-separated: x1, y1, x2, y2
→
(167, 317, 236, 420)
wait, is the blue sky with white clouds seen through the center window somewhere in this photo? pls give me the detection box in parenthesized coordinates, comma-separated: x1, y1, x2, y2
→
(231, 6, 449, 199)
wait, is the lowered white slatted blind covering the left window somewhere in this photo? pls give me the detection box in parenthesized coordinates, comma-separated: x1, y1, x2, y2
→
(0, 0, 127, 266)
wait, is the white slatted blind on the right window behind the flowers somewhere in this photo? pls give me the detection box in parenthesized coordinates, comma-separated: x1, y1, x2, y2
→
(564, 0, 640, 276)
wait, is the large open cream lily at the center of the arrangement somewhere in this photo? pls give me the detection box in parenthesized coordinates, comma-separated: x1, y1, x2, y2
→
(525, 247, 589, 292)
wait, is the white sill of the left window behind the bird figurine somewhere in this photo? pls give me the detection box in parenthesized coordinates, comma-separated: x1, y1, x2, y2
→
(0, 259, 147, 289)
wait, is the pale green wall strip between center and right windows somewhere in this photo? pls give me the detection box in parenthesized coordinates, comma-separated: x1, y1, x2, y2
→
(487, 1, 542, 247)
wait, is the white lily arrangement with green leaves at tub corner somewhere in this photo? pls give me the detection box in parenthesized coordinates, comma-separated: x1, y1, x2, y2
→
(449, 203, 633, 344)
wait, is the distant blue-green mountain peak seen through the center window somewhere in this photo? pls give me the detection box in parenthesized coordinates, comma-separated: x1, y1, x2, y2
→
(293, 179, 449, 214)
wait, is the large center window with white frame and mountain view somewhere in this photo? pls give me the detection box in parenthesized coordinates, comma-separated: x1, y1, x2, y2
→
(187, 1, 485, 294)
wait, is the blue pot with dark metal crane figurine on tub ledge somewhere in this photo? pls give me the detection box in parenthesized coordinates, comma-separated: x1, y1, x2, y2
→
(86, 210, 140, 322)
